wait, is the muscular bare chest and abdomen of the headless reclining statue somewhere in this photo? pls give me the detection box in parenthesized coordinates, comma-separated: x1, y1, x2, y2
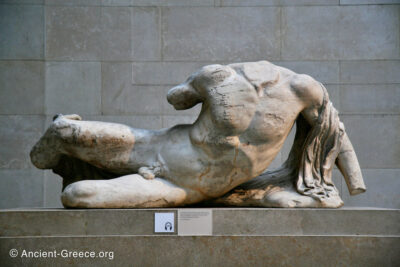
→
(161, 63, 304, 197)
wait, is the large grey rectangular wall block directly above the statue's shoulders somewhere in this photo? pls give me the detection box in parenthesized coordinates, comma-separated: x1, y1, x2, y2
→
(162, 7, 280, 62)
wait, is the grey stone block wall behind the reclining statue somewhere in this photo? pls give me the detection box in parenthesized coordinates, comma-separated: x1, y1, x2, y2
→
(0, 0, 400, 208)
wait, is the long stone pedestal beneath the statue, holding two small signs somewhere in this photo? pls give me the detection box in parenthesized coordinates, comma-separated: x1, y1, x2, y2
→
(0, 208, 400, 266)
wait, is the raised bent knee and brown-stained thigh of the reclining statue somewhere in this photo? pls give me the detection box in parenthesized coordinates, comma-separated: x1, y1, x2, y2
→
(31, 115, 135, 170)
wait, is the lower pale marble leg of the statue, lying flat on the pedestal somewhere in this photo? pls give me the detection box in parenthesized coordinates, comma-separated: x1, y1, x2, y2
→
(61, 174, 204, 208)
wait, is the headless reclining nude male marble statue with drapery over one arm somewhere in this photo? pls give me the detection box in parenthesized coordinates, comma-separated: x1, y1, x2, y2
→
(30, 61, 366, 208)
